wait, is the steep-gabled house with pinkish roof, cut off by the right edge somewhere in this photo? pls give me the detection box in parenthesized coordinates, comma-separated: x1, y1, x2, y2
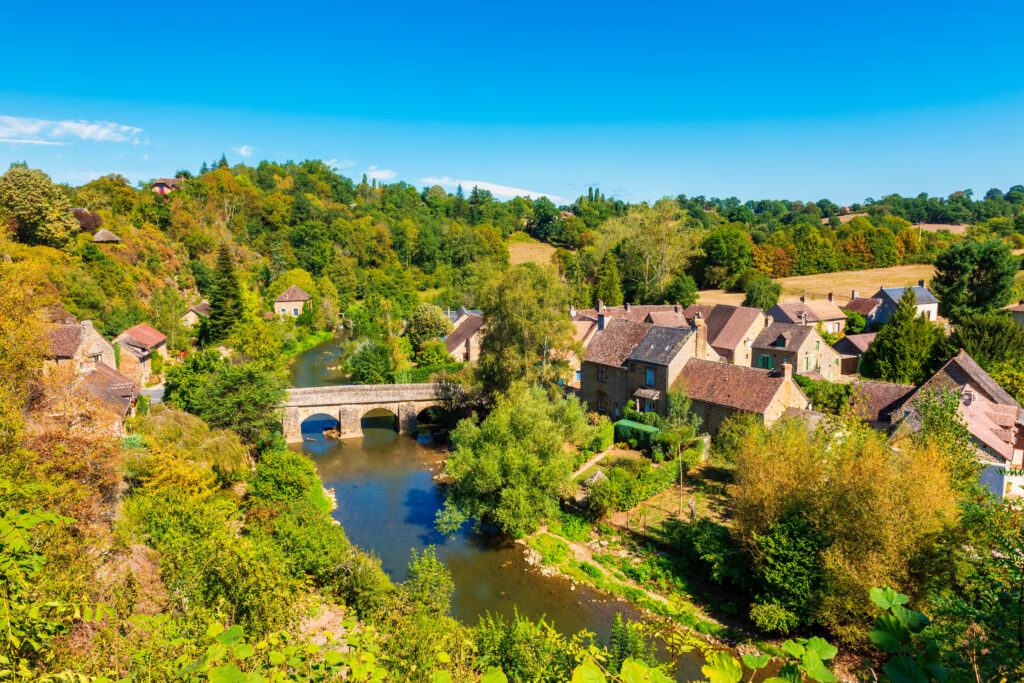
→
(891, 350, 1024, 498)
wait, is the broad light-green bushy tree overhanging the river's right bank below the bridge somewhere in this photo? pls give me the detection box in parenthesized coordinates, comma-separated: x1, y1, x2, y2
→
(437, 384, 594, 538)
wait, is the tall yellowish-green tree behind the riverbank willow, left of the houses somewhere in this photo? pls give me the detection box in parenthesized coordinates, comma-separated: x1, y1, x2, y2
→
(477, 263, 573, 392)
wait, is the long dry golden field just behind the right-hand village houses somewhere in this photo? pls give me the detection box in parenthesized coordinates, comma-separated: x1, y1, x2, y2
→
(697, 263, 935, 306)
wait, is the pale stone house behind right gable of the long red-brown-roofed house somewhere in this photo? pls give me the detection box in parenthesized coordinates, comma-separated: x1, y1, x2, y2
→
(751, 323, 842, 382)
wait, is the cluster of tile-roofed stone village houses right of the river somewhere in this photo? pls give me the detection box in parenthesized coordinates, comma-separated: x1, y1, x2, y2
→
(568, 282, 1024, 496)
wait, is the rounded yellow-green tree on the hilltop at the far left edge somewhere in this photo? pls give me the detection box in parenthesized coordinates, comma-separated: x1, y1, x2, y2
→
(0, 165, 79, 249)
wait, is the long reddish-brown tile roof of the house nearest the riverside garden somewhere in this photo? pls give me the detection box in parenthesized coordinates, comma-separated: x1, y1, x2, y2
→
(673, 358, 802, 415)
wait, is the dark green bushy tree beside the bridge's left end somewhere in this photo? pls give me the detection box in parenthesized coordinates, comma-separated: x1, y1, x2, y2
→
(196, 364, 286, 451)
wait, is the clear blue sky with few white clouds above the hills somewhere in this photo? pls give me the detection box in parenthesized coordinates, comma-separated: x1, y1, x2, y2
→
(0, 1, 1024, 204)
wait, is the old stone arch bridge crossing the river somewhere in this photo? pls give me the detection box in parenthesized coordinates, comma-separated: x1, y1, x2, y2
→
(283, 384, 437, 443)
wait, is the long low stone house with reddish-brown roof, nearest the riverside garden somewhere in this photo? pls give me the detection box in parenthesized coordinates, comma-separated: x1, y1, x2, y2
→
(673, 358, 811, 435)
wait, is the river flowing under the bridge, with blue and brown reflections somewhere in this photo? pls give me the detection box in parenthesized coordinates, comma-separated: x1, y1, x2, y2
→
(291, 340, 699, 680)
